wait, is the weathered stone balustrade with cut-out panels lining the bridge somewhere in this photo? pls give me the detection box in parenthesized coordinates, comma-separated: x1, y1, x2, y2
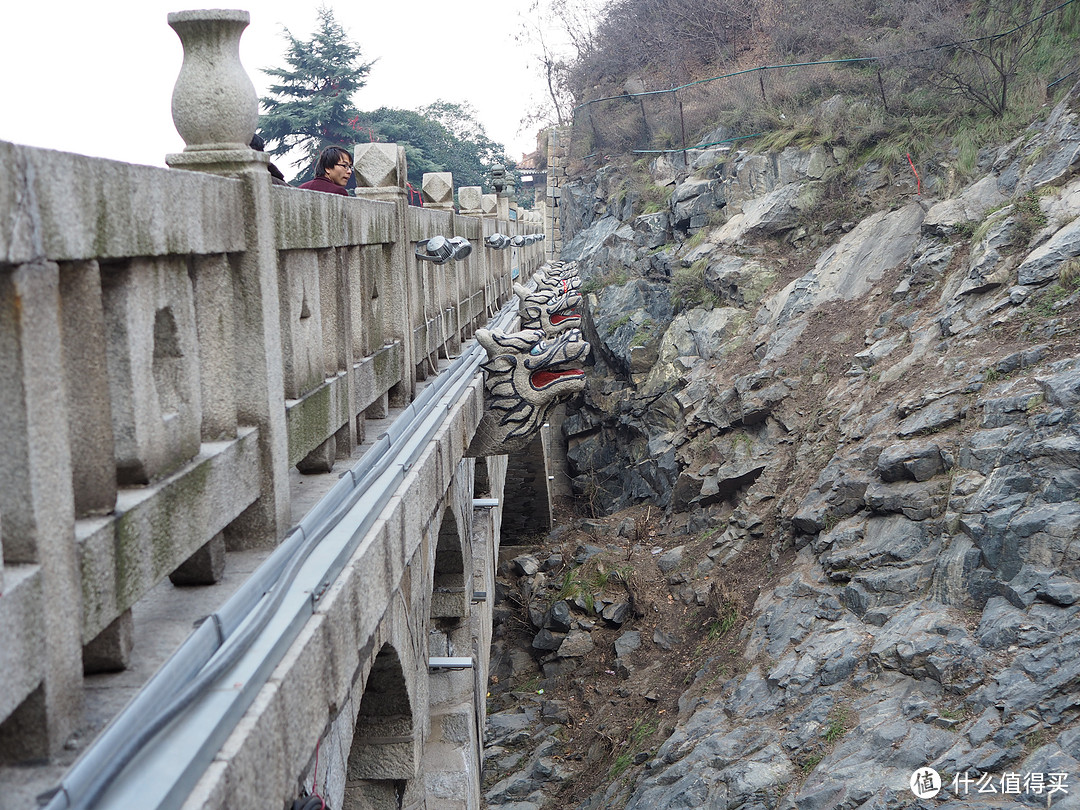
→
(0, 12, 543, 761)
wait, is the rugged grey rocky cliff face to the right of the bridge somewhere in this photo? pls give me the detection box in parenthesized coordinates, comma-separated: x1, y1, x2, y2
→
(488, 90, 1080, 810)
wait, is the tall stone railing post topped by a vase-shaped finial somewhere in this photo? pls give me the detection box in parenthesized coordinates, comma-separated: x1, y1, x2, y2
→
(165, 9, 289, 548)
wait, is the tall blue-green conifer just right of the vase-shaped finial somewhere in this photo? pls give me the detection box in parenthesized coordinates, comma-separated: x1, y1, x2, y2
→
(258, 6, 373, 180)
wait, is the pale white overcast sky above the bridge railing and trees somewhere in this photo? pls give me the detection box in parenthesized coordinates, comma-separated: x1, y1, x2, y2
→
(0, 0, 557, 175)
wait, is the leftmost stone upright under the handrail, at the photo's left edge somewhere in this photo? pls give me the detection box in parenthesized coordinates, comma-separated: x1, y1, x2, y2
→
(0, 261, 83, 762)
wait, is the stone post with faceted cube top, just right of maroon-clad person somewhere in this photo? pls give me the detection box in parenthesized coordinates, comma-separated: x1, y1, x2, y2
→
(352, 144, 423, 408)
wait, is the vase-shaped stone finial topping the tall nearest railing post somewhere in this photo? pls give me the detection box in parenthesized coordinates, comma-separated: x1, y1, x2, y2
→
(168, 9, 259, 152)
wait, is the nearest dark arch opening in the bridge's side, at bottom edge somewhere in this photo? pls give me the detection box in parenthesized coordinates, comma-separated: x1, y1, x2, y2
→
(345, 644, 417, 810)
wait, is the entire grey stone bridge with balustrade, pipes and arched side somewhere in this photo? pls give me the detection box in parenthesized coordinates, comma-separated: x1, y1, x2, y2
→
(0, 12, 565, 810)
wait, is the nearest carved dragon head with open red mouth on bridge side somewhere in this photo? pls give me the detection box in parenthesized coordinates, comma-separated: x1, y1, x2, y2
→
(467, 329, 591, 457)
